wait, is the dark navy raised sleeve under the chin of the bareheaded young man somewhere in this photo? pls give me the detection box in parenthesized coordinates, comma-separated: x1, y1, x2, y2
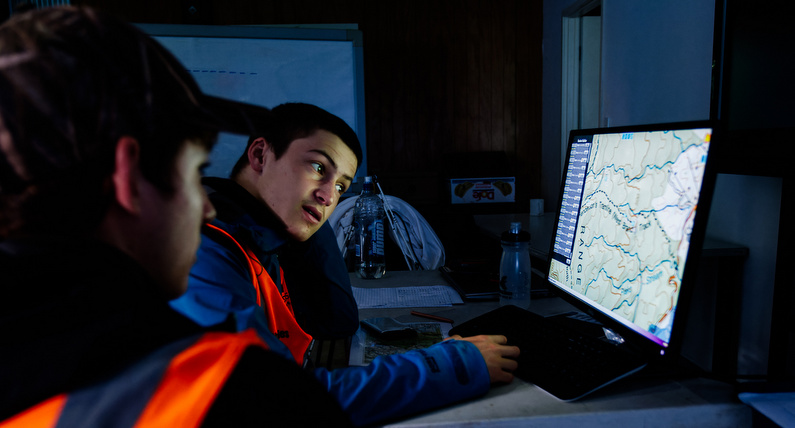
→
(279, 222, 359, 339)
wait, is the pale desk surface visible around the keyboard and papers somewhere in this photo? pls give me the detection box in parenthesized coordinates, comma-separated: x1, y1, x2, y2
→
(351, 271, 752, 428)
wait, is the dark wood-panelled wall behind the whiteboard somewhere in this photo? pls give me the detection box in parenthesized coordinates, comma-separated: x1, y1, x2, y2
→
(73, 0, 542, 258)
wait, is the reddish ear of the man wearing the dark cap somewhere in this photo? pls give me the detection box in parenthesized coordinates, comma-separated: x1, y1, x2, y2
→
(112, 135, 141, 213)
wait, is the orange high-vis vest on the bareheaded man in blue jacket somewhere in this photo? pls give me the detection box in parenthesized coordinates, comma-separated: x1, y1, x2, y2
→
(206, 224, 312, 364)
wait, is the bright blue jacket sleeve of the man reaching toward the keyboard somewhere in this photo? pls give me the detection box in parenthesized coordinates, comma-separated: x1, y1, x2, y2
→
(171, 229, 490, 425)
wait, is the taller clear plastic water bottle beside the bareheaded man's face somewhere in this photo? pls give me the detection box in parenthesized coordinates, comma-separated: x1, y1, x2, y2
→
(353, 177, 386, 279)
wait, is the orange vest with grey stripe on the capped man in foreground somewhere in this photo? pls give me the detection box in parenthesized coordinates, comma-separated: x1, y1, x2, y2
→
(0, 329, 268, 428)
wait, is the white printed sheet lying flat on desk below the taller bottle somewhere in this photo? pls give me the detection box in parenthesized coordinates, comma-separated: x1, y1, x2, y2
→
(351, 285, 463, 309)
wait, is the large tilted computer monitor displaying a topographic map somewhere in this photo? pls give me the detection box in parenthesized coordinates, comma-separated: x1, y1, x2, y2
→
(547, 122, 715, 362)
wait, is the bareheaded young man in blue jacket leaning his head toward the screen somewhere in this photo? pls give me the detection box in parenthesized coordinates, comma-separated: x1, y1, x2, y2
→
(172, 103, 519, 425)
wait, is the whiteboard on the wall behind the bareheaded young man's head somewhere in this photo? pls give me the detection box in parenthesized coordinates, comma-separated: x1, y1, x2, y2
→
(138, 24, 367, 181)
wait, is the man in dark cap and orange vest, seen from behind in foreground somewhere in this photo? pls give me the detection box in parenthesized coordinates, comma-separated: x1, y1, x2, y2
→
(0, 7, 351, 428)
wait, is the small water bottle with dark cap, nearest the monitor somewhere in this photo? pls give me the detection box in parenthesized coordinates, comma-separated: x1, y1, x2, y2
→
(500, 222, 531, 309)
